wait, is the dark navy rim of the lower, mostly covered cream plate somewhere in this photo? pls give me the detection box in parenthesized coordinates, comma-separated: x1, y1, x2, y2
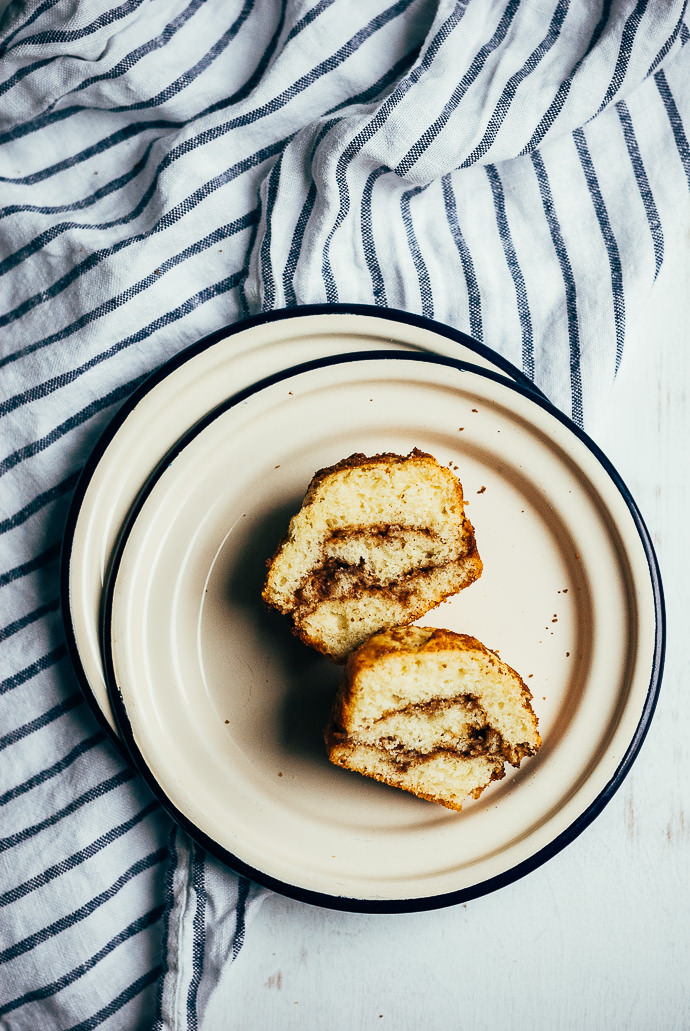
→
(58, 303, 546, 750)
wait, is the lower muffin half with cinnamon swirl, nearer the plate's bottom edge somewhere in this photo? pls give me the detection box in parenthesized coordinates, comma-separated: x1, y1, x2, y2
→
(325, 626, 540, 809)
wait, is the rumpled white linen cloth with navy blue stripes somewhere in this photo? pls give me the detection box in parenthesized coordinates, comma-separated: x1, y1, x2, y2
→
(0, 0, 690, 1031)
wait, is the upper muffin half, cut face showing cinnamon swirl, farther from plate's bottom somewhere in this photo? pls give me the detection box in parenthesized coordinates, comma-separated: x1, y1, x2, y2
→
(262, 448, 482, 662)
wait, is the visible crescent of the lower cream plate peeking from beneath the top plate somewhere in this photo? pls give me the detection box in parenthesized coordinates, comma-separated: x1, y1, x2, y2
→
(62, 305, 527, 730)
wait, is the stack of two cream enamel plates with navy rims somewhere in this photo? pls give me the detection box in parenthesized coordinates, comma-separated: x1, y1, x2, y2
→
(63, 306, 664, 911)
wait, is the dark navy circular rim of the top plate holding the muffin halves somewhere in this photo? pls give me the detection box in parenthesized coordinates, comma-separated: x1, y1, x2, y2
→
(101, 351, 666, 913)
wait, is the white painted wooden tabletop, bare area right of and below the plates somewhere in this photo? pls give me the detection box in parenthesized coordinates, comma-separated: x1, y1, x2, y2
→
(219, 206, 690, 1031)
